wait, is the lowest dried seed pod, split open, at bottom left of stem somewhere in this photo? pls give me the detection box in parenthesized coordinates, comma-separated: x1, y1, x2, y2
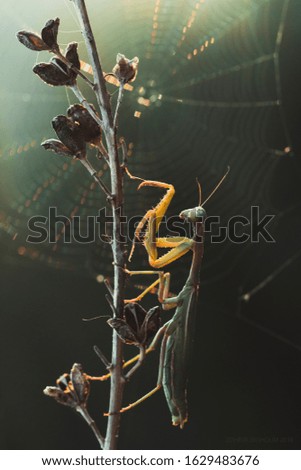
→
(44, 364, 90, 408)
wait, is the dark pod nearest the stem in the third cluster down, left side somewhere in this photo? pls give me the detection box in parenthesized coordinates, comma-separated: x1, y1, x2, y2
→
(67, 104, 101, 147)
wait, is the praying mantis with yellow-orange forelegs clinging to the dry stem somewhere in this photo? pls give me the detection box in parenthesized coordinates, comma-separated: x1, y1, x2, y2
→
(116, 168, 230, 429)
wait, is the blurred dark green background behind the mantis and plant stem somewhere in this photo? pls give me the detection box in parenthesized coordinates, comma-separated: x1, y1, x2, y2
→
(0, 0, 301, 449)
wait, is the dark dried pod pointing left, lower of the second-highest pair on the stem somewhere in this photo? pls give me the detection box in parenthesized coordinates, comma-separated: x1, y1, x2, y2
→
(32, 57, 76, 86)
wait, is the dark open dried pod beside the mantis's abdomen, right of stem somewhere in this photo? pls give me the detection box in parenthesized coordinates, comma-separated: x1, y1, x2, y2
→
(108, 303, 161, 347)
